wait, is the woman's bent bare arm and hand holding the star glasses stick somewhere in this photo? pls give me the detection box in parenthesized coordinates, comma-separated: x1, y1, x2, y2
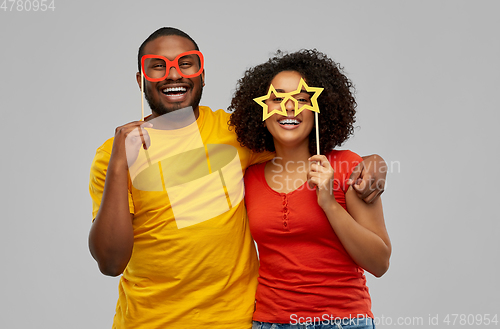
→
(308, 155, 391, 277)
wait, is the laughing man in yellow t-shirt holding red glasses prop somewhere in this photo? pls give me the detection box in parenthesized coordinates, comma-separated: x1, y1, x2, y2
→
(89, 28, 385, 329)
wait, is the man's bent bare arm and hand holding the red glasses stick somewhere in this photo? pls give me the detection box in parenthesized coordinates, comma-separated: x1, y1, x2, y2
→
(89, 121, 150, 276)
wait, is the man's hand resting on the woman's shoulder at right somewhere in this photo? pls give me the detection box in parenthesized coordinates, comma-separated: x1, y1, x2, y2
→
(347, 154, 387, 203)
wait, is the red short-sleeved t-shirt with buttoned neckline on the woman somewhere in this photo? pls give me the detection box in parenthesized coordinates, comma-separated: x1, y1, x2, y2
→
(245, 150, 373, 323)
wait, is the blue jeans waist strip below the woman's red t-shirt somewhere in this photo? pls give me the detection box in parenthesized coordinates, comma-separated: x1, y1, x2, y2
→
(252, 318, 375, 329)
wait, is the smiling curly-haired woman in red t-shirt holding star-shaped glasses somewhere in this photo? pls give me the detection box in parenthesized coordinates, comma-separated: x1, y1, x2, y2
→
(229, 50, 391, 328)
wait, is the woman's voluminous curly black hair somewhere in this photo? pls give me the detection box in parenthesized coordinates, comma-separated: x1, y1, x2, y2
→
(228, 49, 357, 154)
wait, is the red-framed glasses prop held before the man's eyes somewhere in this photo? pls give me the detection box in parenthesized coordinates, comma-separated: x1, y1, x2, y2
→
(141, 50, 203, 82)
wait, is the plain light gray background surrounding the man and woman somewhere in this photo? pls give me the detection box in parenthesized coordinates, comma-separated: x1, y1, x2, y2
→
(0, 0, 500, 328)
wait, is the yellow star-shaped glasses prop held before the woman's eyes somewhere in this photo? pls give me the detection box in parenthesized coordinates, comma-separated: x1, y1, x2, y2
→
(253, 78, 324, 121)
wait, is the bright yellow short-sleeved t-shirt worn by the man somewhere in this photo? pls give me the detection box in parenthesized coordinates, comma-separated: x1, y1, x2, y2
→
(90, 106, 272, 329)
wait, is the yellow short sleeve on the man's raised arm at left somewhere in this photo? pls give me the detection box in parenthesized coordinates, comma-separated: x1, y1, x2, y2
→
(89, 139, 134, 220)
